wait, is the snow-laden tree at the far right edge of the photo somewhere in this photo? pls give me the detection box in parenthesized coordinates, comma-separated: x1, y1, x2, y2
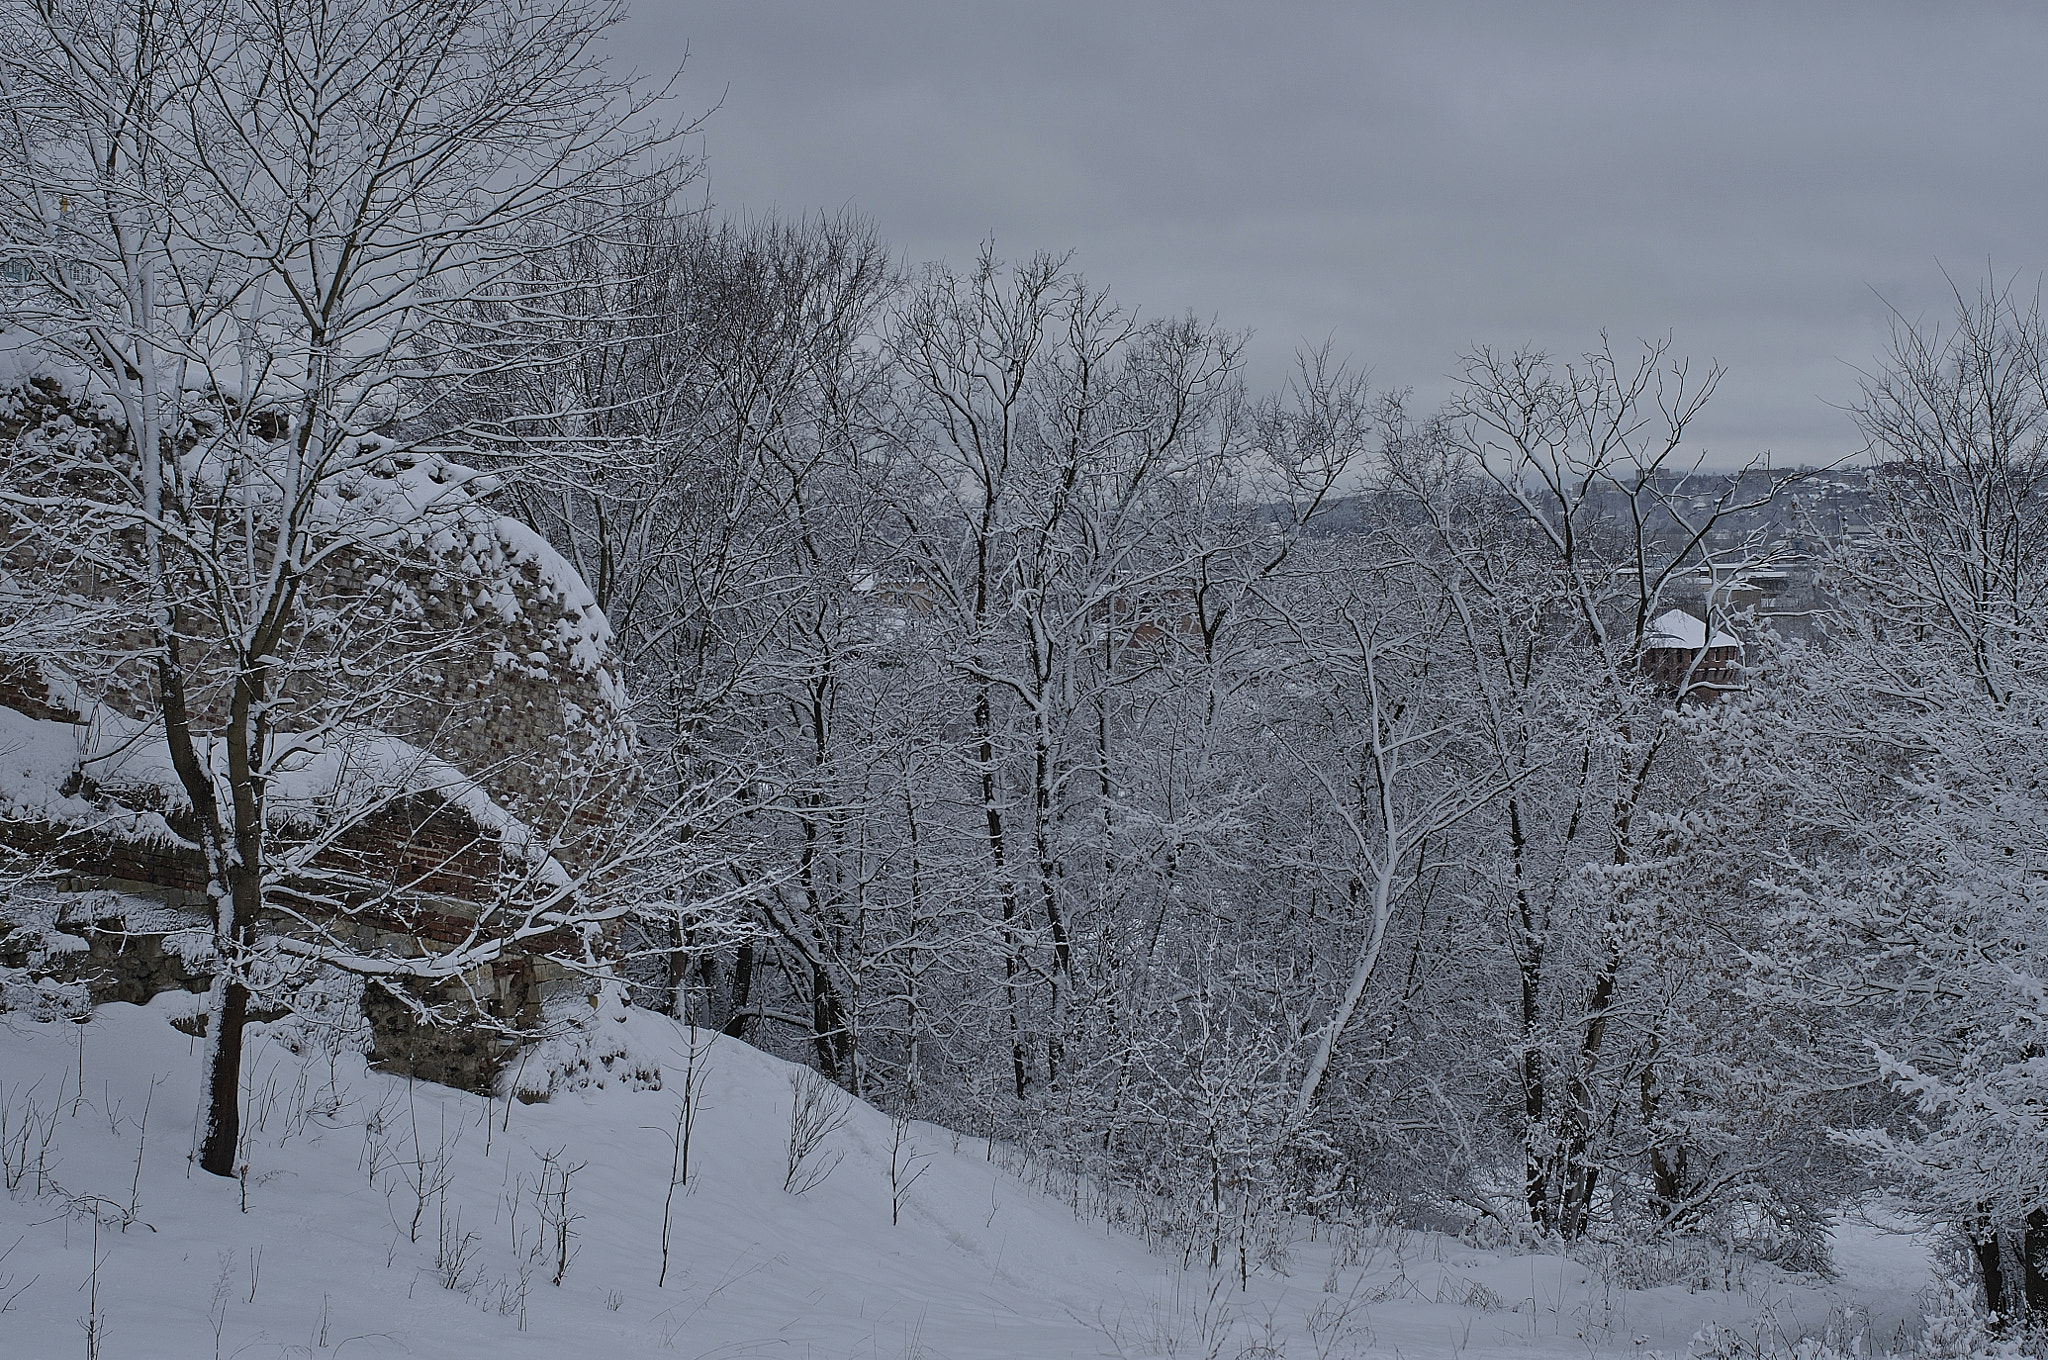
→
(1731, 279, 2048, 1329)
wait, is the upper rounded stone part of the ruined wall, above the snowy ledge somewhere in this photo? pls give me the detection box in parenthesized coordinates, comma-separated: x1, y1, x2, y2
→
(0, 366, 637, 866)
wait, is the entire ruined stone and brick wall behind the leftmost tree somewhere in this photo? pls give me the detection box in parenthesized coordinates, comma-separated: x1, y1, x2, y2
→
(0, 358, 635, 1090)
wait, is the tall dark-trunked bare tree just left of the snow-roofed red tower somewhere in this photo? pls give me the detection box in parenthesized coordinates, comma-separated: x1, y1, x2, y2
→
(1393, 342, 1790, 1237)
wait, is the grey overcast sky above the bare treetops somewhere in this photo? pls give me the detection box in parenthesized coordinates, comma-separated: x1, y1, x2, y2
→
(621, 0, 2048, 463)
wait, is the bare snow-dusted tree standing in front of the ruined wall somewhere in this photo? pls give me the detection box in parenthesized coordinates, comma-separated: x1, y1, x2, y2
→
(0, 0, 692, 1176)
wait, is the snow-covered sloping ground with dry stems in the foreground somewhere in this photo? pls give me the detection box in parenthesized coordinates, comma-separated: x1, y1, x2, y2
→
(0, 997, 1929, 1360)
